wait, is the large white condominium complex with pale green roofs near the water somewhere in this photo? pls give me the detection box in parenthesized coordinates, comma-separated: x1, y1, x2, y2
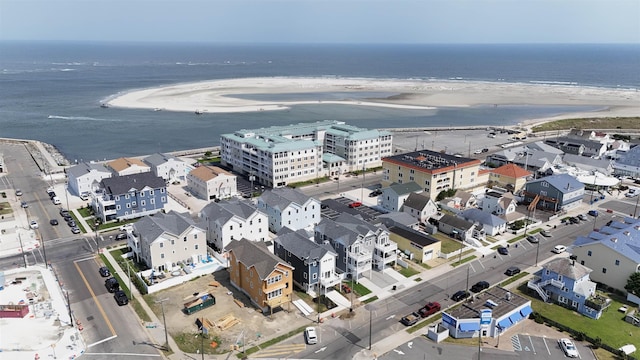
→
(220, 120, 393, 187)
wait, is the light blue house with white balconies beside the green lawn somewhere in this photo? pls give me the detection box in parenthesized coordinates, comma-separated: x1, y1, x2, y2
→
(527, 258, 609, 319)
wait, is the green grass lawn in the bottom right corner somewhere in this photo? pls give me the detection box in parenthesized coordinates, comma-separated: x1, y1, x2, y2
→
(518, 284, 640, 349)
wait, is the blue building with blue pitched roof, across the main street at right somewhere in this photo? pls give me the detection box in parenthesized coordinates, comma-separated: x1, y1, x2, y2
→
(523, 174, 584, 212)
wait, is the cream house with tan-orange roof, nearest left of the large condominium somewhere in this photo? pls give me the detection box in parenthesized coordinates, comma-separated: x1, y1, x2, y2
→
(187, 166, 238, 200)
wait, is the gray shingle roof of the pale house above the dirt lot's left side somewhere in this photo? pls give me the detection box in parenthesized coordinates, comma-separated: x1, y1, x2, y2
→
(133, 211, 204, 241)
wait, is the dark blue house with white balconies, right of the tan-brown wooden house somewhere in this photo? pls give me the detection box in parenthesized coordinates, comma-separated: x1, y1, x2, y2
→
(273, 228, 341, 294)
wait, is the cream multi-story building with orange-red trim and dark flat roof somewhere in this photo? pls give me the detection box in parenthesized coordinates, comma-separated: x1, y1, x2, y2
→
(382, 150, 481, 200)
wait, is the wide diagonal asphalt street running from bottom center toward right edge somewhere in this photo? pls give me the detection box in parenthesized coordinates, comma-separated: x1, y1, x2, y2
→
(292, 212, 615, 359)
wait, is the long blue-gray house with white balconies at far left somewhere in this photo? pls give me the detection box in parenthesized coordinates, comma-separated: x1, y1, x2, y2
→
(93, 172, 167, 222)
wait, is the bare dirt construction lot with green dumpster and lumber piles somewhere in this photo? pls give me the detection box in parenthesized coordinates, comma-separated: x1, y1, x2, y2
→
(145, 270, 315, 350)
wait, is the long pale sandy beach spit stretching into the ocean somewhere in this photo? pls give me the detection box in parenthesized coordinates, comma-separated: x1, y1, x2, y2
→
(107, 77, 640, 123)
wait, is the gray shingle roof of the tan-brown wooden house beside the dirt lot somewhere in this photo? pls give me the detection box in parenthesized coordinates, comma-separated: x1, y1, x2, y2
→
(227, 238, 293, 280)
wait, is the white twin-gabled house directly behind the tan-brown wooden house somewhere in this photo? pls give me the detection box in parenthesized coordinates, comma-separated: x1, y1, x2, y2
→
(200, 200, 269, 252)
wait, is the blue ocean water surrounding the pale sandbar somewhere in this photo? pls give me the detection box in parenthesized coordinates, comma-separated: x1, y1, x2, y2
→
(0, 42, 640, 161)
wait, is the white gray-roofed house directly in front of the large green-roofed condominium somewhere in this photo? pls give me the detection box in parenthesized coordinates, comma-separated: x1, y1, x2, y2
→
(258, 188, 322, 233)
